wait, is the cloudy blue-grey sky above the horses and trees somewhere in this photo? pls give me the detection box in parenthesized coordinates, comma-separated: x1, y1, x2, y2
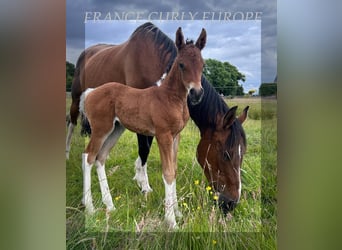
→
(66, 0, 277, 92)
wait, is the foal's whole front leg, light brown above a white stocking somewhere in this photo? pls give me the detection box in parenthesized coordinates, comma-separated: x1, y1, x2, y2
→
(156, 134, 177, 228)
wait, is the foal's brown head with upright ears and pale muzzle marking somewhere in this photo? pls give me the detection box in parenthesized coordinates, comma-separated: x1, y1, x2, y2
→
(174, 27, 207, 105)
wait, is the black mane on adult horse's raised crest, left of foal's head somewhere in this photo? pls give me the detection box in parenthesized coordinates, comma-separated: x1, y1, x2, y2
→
(129, 22, 177, 73)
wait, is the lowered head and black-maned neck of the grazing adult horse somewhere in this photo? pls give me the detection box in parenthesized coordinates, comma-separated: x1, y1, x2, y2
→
(188, 76, 249, 214)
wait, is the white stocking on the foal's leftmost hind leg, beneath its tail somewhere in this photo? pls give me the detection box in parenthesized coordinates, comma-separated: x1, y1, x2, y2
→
(82, 153, 95, 214)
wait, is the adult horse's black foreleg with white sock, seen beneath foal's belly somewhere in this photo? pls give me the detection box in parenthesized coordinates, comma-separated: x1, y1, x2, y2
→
(133, 134, 153, 193)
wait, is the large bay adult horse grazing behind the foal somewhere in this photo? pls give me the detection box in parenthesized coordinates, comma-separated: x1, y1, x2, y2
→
(66, 22, 248, 213)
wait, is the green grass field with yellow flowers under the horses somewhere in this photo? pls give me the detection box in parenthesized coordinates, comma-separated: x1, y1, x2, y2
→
(66, 98, 277, 249)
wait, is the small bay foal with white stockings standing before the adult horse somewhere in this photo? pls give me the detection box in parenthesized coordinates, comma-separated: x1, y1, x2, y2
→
(80, 28, 207, 228)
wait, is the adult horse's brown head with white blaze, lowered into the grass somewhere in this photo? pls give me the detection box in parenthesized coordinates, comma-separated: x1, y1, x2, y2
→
(197, 106, 249, 214)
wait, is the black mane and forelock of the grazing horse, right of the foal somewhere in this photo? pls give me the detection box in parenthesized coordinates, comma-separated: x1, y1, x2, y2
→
(188, 75, 246, 148)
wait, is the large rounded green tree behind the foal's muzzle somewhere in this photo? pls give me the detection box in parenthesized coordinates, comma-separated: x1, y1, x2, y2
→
(203, 59, 246, 96)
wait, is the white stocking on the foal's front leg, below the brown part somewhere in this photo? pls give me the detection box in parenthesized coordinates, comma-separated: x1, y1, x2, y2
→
(163, 175, 177, 228)
